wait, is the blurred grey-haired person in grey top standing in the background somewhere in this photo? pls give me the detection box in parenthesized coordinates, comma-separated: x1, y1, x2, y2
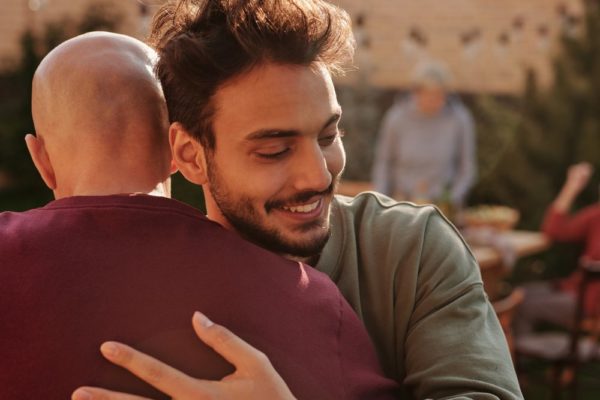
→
(373, 63, 476, 208)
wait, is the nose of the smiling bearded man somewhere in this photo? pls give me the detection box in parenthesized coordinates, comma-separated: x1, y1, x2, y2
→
(293, 144, 332, 192)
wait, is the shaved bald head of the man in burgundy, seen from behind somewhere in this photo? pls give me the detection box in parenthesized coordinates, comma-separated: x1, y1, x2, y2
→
(27, 32, 171, 198)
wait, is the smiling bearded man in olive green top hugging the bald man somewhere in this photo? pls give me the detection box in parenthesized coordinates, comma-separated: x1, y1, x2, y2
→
(81, 0, 522, 399)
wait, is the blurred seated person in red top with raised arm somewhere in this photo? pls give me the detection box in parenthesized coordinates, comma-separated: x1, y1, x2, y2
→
(515, 162, 600, 334)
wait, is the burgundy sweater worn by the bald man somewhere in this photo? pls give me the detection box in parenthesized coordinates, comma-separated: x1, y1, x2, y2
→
(0, 195, 397, 400)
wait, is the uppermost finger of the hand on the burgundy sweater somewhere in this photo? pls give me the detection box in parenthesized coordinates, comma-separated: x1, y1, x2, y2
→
(192, 312, 271, 373)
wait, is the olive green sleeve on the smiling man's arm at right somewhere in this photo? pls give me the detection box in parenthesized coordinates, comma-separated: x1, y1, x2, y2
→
(404, 212, 522, 399)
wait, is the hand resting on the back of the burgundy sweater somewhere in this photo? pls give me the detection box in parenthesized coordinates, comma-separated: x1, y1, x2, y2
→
(72, 312, 294, 400)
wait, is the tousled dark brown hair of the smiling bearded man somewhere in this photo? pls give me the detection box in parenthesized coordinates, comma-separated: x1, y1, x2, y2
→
(151, 0, 354, 149)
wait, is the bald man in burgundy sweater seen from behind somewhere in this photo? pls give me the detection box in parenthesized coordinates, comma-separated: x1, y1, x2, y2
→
(0, 32, 397, 400)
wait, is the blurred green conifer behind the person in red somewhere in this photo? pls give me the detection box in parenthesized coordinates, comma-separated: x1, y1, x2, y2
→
(470, 1, 600, 229)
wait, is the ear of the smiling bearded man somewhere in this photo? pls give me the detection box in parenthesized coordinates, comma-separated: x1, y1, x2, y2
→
(169, 122, 208, 185)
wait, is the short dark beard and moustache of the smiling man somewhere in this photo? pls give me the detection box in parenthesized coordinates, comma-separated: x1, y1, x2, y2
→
(207, 155, 335, 258)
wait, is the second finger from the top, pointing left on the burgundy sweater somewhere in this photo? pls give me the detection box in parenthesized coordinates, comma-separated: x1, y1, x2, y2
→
(94, 342, 201, 400)
